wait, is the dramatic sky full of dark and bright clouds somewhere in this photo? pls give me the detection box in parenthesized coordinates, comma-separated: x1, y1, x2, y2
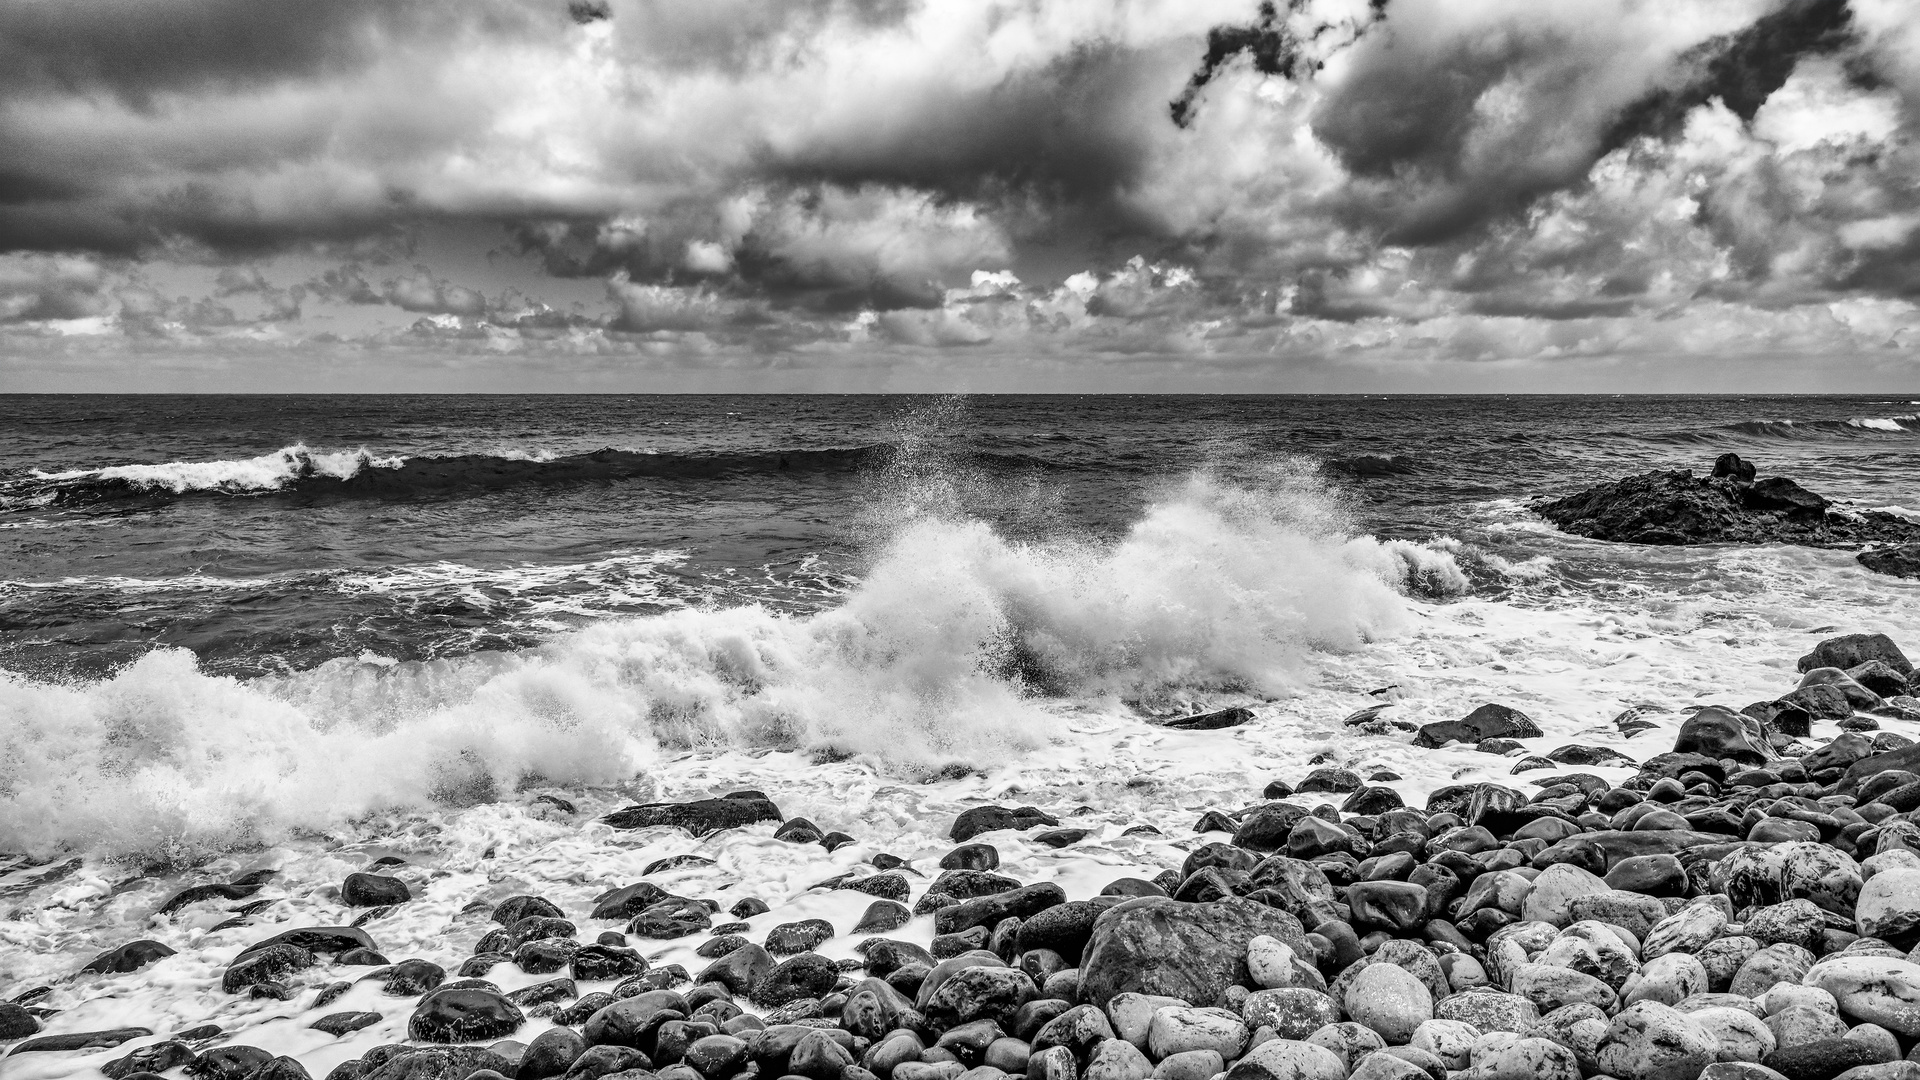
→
(0, 0, 1920, 392)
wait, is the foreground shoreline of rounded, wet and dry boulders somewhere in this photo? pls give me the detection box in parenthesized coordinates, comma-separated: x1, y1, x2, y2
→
(18, 634, 1920, 1080)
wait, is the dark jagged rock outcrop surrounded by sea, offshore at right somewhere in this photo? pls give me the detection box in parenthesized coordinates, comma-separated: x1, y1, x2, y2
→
(1534, 454, 1920, 577)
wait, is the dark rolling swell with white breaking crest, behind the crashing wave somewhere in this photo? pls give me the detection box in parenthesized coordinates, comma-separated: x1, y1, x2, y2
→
(0, 444, 893, 509)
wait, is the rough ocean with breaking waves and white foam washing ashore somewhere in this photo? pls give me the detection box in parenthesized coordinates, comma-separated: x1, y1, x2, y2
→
(0, 396, 1920, 1076)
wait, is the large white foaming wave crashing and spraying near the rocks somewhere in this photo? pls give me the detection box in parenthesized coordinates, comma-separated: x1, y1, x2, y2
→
(0, 466, 1465, 863)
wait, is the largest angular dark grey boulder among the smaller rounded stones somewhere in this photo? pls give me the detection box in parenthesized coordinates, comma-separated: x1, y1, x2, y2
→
(1081, 897, 1306, 1009)
